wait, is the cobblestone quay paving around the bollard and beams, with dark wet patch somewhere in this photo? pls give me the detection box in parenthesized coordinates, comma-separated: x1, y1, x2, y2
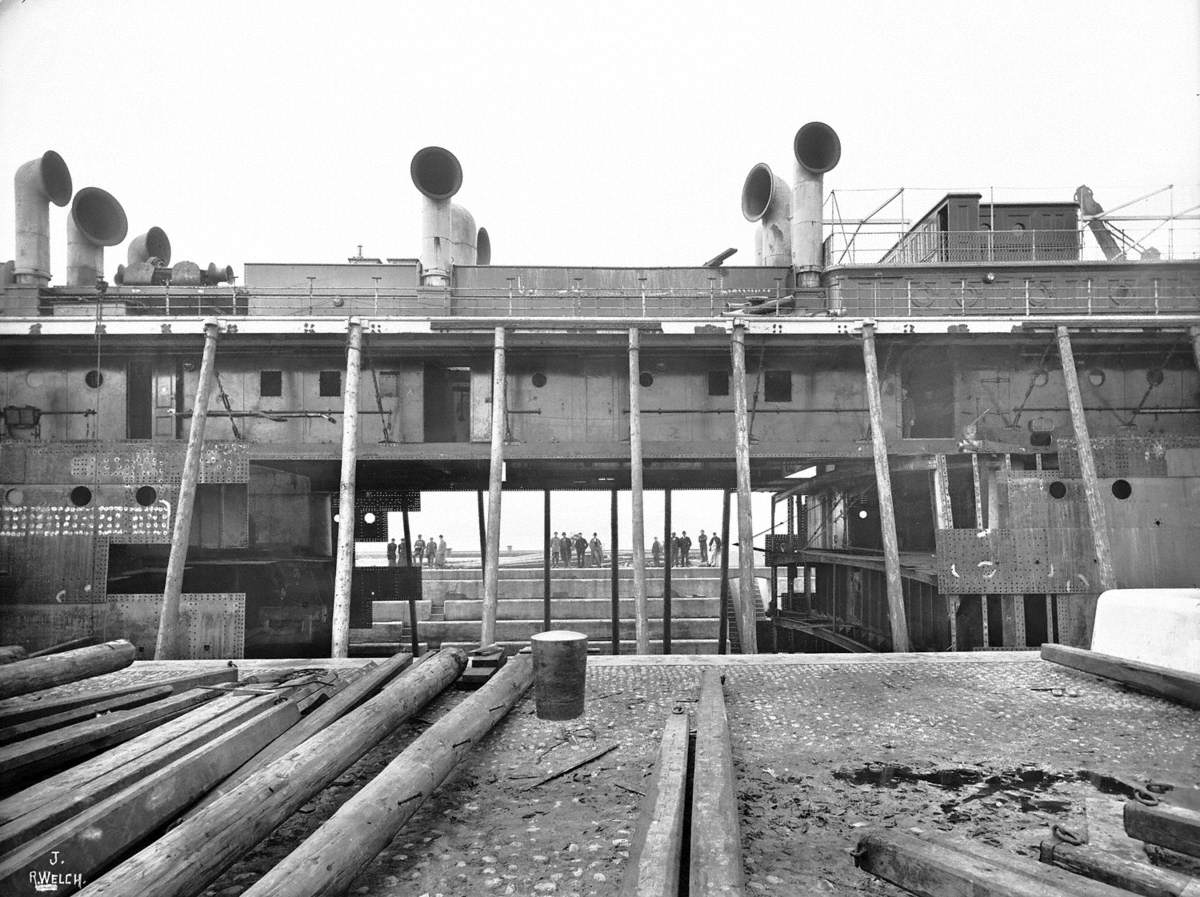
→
(192, 655, 1200, 897)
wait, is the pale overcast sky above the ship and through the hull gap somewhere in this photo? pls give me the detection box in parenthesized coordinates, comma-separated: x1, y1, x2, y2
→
(0, 0, 1200, 544)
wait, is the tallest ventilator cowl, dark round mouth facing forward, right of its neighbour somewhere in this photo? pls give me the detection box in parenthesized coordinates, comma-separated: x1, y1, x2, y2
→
(792, 121, 841, 280)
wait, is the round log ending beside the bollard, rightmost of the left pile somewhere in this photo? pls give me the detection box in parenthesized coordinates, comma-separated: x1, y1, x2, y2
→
(236, 655, 533, 897)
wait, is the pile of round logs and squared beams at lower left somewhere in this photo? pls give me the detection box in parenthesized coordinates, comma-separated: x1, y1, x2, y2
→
(0, 642, 547, 897)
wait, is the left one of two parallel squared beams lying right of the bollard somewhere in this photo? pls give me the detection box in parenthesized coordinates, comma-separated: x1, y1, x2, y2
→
(620, 712, 689, 897)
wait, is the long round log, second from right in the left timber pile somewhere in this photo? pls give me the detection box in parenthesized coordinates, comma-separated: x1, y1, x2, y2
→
(82, 648, 468, 897)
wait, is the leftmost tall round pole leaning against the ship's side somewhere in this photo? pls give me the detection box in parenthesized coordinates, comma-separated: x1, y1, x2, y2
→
(154, 318, 220, 661)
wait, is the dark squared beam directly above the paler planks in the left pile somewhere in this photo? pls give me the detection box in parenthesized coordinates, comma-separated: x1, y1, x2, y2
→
(0, 688, 217, 784)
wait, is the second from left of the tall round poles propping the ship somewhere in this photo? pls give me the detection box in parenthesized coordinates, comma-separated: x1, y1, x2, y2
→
(330, 318, 362, 657)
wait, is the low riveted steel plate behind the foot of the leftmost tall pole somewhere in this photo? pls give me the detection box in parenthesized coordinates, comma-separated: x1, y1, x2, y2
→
(104, 592, 246, 660)
